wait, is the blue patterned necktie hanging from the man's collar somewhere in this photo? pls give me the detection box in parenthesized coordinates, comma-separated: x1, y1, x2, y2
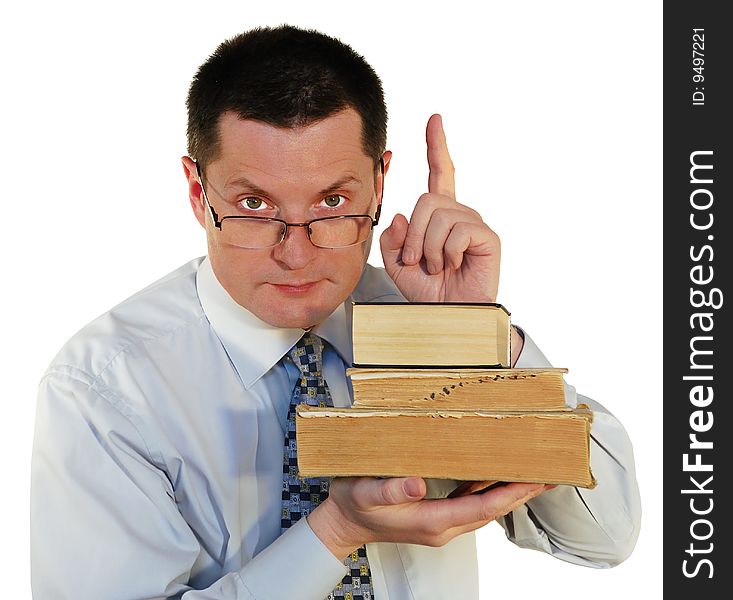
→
(282, 332, 374, 600)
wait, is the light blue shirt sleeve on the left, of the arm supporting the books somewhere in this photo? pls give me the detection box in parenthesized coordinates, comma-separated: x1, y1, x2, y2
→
(31, 368, 346, 600)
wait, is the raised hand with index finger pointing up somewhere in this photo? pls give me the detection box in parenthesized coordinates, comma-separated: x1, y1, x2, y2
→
(380, 114, 501, 302)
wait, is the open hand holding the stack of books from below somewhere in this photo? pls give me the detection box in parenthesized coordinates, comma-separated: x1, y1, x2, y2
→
(308, 477, 554, 559)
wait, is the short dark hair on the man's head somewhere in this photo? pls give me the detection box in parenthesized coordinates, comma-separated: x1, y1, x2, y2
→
(186, 25, 387, 167)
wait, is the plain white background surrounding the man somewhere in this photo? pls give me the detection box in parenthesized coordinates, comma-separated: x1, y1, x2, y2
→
(0, 0, 662, 600)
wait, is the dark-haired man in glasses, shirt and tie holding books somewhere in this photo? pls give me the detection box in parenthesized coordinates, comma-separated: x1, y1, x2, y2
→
(31, 27, 640, 600)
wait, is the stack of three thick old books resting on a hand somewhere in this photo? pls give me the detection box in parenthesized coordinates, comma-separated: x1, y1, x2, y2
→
(296, 303, 596, 492)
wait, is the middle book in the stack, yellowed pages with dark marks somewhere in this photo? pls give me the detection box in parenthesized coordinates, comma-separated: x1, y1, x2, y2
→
(346, 367, 567, 410)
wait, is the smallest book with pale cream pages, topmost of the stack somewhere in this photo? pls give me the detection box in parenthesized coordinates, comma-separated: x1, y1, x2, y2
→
(352, 302, 511, 369)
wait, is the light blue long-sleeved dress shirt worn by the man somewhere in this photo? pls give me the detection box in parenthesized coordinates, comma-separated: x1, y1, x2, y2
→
(31, 258, 641, 600)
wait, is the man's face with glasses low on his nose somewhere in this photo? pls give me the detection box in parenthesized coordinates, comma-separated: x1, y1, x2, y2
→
(184, 109, 382, 328)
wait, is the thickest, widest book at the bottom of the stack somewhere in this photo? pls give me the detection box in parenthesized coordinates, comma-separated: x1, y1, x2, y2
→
(296, 404, 596, 488)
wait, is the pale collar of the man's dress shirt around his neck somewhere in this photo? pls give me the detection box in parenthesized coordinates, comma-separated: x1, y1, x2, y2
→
(196, 257, 353, 388)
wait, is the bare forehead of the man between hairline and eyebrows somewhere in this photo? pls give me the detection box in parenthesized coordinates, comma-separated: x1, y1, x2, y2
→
(210, 109, 373, 180)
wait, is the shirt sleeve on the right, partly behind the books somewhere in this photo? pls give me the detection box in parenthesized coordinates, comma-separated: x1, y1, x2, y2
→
(499, 332, 641, 568)
